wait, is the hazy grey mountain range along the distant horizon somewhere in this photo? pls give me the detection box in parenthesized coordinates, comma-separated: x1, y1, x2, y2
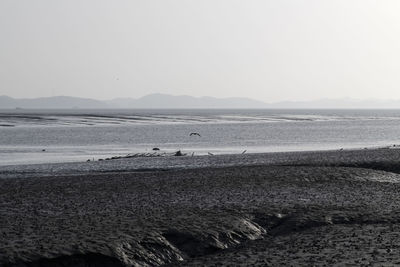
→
(0, 94, 400, 109)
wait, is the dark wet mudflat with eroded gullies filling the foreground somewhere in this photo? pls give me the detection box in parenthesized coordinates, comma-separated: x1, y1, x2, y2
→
(0, 149, 400, 266)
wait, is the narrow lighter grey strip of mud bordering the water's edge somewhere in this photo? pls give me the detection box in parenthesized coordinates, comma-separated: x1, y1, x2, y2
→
(0, 145, 400, 179)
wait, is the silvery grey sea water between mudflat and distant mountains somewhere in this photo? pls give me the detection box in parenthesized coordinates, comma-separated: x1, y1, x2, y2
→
(0, 110, 400, 165)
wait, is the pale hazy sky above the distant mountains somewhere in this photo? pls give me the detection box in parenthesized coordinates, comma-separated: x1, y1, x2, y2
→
(0, 0, 400, 102)
